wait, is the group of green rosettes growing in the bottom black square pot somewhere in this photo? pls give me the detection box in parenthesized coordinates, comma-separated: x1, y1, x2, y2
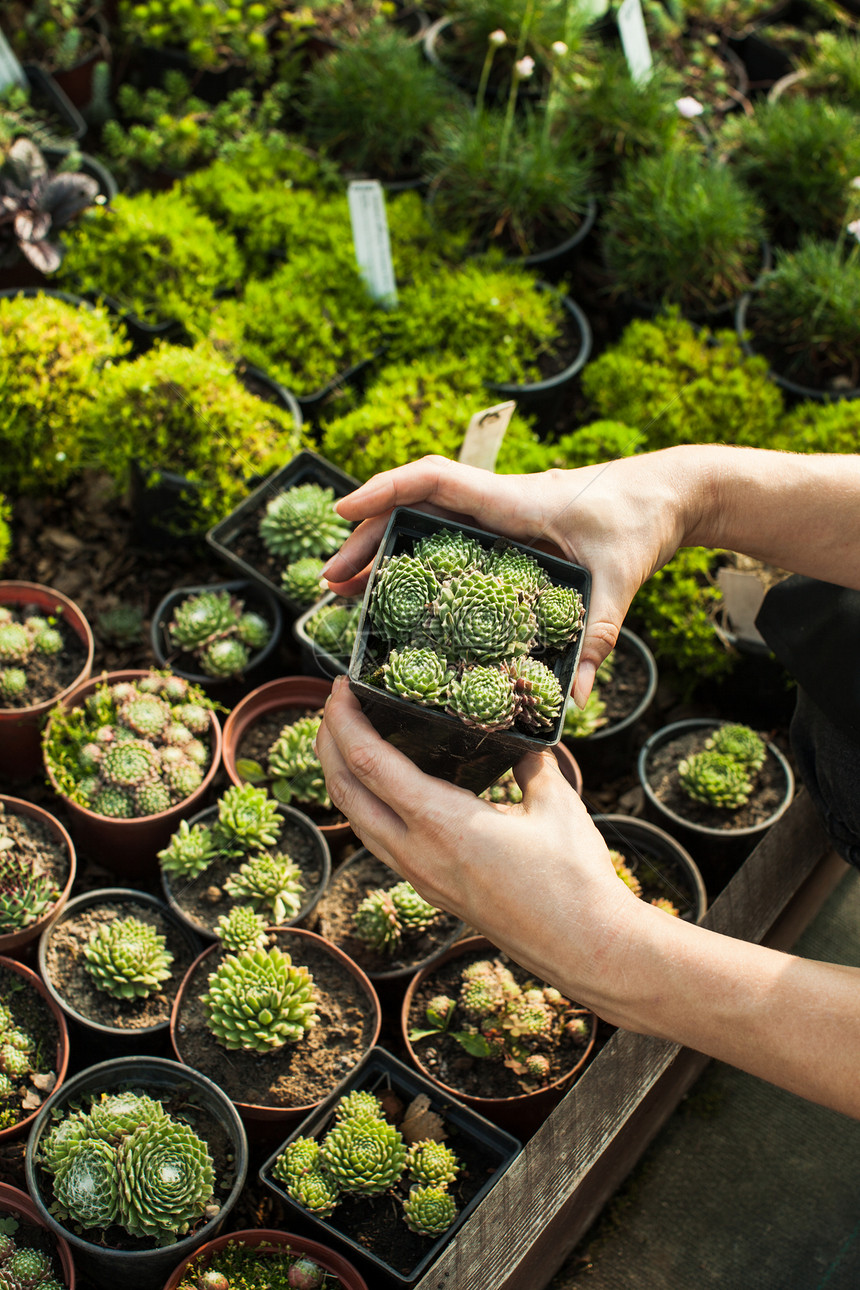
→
(272, 1090, 462, 1236)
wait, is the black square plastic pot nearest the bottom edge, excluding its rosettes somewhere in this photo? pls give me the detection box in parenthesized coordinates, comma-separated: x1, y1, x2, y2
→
(259, 1047, 522, 1290)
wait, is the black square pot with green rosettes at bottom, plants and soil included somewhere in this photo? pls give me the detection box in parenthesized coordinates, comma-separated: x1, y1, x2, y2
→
(260, 1047, 521, 1286)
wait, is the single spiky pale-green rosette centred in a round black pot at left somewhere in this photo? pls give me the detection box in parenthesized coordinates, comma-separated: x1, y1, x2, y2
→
(84, 916, 173, 998)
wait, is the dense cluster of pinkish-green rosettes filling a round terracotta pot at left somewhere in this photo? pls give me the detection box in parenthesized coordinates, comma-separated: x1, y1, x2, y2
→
(43, 671, 213, 819)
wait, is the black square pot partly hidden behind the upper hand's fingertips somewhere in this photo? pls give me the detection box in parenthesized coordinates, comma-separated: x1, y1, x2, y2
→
(206, 450, 358, 618)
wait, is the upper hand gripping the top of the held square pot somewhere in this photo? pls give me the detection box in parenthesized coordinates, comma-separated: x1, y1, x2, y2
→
(324, 450, 685, 707)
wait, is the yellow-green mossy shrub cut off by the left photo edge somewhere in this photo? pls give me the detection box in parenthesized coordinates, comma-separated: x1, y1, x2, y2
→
(0, 295, 128, 493)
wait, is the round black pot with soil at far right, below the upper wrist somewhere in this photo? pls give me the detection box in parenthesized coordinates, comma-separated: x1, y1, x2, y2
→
(637, 717, 794, 899)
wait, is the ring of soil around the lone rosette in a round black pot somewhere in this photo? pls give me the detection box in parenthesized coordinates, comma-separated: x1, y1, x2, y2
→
(46, 900, 196, 1031)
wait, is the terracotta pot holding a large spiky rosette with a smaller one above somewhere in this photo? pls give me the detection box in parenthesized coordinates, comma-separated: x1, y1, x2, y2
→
(170, 928, 382, 1138)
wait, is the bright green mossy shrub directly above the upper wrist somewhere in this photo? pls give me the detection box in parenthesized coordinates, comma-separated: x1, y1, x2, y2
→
(581, 311, 783, 449)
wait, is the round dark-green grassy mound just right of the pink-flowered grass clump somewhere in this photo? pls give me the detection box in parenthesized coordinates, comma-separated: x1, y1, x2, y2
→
(602, 147, 763, 311)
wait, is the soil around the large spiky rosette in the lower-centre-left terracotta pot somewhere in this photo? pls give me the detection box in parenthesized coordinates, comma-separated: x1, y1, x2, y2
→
(177, 933, 374, 1109)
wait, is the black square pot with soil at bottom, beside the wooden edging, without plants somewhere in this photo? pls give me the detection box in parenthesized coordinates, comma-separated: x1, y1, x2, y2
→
(259, 1047, 522, 1290)
